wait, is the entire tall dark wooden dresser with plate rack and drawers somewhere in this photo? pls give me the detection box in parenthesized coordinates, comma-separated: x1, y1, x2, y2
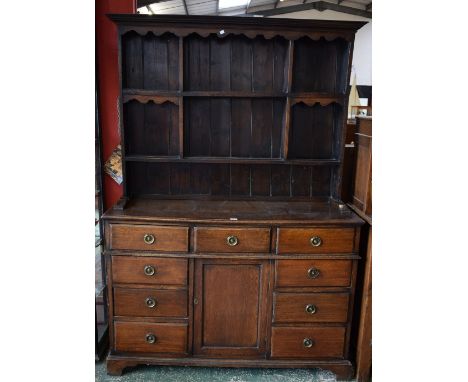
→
(104, 15, 363, 378)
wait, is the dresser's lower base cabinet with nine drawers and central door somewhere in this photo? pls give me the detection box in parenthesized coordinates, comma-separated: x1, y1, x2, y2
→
(105, 200, 362, 379)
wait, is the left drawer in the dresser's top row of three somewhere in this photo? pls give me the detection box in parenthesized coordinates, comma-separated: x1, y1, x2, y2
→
(109, 224, 188, 252)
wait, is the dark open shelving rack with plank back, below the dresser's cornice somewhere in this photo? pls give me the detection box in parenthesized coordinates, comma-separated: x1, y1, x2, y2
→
(120, 18, 354, 199)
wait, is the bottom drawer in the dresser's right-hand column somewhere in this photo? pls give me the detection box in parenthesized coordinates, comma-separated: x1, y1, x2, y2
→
(271, 327, 346, 358)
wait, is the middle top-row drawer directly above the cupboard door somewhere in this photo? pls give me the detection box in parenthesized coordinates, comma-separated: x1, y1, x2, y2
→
(195, 227, 270, 253)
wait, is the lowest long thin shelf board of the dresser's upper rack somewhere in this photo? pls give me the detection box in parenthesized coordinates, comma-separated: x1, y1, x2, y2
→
(125, 155, 341, 166)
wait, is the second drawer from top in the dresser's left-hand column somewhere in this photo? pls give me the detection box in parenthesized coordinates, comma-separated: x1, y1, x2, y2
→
(112, 256, 187, 285)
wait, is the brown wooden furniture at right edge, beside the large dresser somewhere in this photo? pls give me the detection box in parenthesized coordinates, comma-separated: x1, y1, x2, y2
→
(350, 117, 372, 382)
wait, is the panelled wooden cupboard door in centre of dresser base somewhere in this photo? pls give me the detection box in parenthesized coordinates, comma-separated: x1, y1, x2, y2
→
(194, 259, 271, 358)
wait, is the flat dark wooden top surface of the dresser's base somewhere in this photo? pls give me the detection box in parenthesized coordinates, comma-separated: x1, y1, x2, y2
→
(104, 198, 363, 225)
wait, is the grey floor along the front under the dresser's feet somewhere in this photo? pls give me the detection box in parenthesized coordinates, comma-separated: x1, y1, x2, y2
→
(96, 361, 352, 382)
